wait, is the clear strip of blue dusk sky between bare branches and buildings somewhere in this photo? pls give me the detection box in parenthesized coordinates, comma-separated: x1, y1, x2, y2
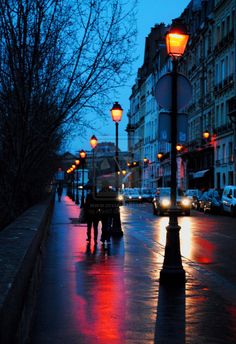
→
(65, 0, 190, 153)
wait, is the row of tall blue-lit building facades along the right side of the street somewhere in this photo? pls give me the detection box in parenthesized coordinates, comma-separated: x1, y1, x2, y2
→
(127, 0, 236, 189)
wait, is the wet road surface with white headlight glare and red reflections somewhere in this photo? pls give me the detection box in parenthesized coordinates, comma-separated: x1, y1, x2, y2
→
(123, 204, 236, 299)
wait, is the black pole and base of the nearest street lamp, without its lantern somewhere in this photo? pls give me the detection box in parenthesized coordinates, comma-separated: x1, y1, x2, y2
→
(160, 59, 185, 284)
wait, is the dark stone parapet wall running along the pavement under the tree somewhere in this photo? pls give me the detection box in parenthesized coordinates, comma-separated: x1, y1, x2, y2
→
(0, 195, 54, 344)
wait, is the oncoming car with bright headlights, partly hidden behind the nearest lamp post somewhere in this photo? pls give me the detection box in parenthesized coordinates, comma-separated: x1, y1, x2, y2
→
(152, 188, 191, 215)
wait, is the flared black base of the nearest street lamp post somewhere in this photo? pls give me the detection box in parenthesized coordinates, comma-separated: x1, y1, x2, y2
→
(160, 208, 186, 285)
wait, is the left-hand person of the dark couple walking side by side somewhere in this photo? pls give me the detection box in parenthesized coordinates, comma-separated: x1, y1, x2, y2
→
(84, 187, 99, 245)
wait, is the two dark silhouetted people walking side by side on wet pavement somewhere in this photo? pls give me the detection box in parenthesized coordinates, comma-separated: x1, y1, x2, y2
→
(84, 185, 119, 245)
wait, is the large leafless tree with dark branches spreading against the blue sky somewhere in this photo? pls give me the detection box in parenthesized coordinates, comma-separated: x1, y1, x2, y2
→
(0, 0, 136, 228)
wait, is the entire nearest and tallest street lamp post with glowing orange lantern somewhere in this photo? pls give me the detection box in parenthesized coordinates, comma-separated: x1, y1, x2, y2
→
(160, 20, 189, 284)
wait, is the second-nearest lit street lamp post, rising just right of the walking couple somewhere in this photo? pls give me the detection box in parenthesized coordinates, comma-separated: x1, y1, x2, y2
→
(110, 102, 123, 236)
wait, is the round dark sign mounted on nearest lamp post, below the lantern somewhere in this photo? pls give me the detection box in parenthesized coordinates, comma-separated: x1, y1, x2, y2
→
(155, 73, 192, 111)
